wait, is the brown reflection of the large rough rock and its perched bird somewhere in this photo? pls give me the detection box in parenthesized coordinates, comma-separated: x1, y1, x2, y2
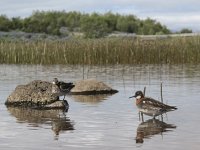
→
(7, 107, 74, 138)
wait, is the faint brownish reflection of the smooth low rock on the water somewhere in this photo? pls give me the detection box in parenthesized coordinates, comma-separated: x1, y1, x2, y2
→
(72, 94, 112, 104)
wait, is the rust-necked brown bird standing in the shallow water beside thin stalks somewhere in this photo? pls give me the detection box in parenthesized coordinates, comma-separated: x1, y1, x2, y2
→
(129, 91, 177, 119)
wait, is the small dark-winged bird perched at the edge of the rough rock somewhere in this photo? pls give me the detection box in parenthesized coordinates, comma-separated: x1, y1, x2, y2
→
(52, 78, 75, 100)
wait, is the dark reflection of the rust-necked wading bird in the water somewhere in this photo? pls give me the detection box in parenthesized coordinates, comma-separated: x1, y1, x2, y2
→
(136, 119, 176, 143)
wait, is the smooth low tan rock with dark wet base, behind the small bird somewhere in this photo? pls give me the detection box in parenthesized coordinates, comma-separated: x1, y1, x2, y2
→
(71, 79, 118, 95)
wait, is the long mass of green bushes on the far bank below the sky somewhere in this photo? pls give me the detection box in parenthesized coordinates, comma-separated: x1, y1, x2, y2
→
(0, 11, 170, 38)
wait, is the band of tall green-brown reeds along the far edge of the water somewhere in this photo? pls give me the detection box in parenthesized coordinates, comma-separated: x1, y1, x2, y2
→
(0, 36, 200, 65)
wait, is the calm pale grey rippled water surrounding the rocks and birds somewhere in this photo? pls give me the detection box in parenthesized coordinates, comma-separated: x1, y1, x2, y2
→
(0, 65, 200, 150)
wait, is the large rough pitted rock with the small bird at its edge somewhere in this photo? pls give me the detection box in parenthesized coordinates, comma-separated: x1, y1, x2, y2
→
(5, 80, 68, 109)
